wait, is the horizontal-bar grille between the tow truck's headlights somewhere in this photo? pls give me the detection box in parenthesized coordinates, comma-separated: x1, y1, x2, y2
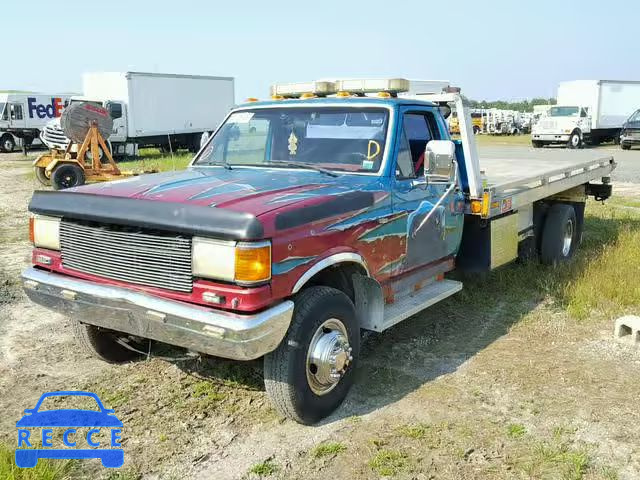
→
(60, 220, 193, 292)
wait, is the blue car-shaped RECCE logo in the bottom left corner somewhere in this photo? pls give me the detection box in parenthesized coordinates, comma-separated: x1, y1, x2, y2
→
(16, 391, 124, 468)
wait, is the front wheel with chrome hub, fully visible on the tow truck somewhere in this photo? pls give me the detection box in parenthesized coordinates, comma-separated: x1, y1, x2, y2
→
(264, 287, 360, 425)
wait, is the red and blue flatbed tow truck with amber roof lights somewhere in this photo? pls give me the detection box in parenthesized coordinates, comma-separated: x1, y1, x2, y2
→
(22, 79, 616, 424)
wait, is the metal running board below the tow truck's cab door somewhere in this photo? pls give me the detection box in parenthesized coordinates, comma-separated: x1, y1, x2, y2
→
(373, 280, 462, 332)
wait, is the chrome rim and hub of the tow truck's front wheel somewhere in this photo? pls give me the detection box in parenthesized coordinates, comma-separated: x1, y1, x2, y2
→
(306, 318, 353, 395)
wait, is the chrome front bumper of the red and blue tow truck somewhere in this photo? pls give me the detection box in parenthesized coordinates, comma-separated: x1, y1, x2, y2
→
(22, 267, 293, 360)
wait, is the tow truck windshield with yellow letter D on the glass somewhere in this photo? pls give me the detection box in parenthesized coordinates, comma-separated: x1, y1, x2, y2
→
(194, 107, 389, 173)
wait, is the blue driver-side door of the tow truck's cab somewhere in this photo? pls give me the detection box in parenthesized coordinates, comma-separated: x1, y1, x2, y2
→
(392, 107, 464, 274)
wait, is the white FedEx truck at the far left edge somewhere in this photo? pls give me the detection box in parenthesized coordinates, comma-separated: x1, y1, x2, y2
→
(0, 93, 71, 152)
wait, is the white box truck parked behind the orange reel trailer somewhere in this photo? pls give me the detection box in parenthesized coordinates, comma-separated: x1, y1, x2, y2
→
(41, 72, 235, 156)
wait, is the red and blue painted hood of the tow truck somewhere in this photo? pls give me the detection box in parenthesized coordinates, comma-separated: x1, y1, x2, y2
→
(71, 167, 382, 217)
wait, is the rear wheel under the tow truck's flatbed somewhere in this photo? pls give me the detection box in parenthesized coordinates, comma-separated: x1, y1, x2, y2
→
(540, 203, 580, 266)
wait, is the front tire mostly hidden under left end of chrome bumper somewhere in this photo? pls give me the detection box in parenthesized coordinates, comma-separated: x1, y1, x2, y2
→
(73, 319, 142, 363)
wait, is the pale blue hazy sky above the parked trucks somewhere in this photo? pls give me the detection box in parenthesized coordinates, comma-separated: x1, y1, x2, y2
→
(6, 0, 640, 101)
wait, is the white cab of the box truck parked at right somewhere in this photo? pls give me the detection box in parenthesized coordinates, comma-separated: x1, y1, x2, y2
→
(531, 105, 591, 148)
